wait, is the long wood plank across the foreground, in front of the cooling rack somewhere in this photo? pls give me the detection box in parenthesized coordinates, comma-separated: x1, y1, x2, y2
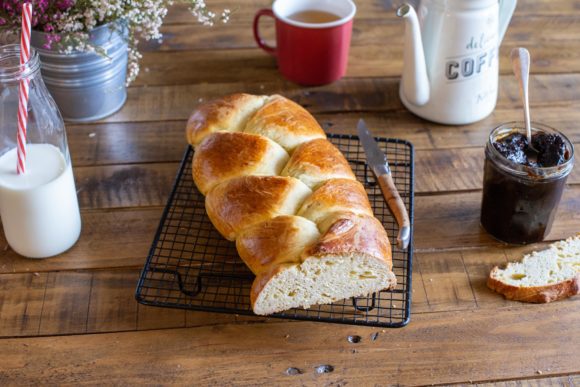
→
(0, 301, 580, 385)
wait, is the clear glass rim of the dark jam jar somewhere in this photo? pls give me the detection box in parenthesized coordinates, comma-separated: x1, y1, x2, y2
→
(487, 121, 574, 179)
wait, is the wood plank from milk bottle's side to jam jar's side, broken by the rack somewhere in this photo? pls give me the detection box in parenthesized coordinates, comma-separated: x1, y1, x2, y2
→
(69, 148, 580, 209)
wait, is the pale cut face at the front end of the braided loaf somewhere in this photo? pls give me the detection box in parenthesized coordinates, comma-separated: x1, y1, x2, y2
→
(251, 253, 397, 315)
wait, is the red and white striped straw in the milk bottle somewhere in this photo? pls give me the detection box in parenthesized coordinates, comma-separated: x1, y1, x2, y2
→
(16, 3, 32, 175)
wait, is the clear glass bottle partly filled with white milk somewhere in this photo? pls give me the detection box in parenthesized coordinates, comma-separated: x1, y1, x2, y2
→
(0, 45, 81, 258)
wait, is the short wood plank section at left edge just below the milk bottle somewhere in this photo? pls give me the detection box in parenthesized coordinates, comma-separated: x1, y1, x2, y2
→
(0, 274, 48, 338)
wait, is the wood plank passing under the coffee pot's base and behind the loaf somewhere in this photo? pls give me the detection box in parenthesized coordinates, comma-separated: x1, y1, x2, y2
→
(62, 103, 580, 172)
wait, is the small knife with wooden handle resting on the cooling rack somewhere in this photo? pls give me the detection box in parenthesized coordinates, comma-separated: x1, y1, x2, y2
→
(357, 119, 411, 250)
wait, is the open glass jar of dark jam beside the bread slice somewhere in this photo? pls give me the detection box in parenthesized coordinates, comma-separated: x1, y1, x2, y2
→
(481, 122, 574, 244)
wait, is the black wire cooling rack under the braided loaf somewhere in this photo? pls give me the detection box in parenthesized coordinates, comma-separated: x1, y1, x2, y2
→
(135, 135, 414, 327)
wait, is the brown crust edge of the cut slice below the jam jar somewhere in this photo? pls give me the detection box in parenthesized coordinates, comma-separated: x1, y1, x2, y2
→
(487, 266, 580, 304)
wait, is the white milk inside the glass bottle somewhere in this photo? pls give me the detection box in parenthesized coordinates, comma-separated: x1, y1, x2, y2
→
(0, 144, 81, 258)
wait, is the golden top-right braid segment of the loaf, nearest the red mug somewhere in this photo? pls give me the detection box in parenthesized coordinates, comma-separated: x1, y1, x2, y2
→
(244, 95, 326, 152)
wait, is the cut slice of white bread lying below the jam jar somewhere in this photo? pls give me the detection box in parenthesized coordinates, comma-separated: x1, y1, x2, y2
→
(487, 234, 580, 303)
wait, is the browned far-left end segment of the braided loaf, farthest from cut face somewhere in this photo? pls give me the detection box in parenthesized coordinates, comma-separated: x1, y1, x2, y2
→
(185, 93, 267, 146)
